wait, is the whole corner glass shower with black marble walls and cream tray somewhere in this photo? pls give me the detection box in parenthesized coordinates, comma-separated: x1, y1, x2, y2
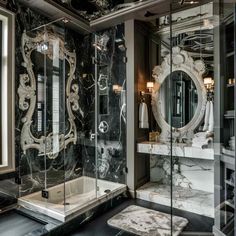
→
(18, 20, 126, 221)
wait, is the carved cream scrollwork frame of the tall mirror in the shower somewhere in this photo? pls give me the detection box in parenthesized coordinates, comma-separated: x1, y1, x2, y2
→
(18, 29, 79, 159)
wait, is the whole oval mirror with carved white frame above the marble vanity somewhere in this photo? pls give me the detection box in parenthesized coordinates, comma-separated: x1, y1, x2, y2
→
(152, 47, 207, 142)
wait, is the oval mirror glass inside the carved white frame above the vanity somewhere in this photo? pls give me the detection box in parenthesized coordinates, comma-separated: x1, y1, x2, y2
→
(159, 70, 198, 128)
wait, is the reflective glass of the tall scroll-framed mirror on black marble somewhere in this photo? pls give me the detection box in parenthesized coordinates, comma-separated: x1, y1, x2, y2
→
(31, 42, 66, 139)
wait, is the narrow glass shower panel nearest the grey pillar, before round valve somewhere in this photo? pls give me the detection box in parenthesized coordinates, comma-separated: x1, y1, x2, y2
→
(95, 24, 126, 185)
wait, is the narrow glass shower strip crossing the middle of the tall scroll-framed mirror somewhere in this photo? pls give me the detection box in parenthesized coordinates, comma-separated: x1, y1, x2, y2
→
(40, 23, 68, 205)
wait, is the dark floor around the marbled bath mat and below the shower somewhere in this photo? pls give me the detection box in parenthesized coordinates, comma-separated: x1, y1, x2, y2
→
(0, 198, 214, 236)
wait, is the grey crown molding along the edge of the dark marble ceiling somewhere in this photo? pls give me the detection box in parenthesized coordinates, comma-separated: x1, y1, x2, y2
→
(18, 0, 214, 34)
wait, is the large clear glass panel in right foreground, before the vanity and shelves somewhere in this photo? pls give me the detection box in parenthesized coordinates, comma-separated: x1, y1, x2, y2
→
(169, 1, 228, 235)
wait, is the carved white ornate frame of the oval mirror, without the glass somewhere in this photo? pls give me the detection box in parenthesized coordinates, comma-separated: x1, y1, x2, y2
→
(152, 47, 207, 142)
